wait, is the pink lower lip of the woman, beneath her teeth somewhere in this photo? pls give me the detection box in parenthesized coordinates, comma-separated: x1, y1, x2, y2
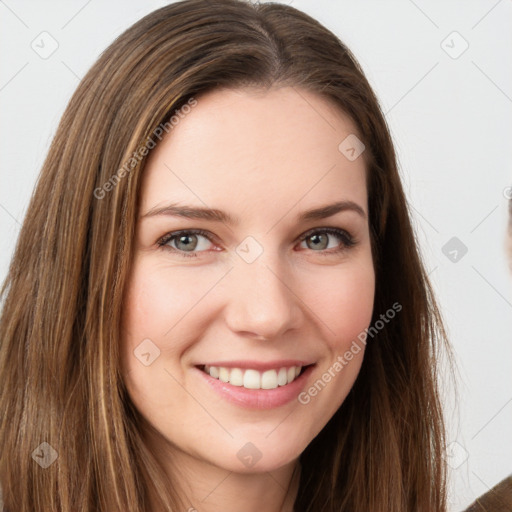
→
(195, 364, 315, 409)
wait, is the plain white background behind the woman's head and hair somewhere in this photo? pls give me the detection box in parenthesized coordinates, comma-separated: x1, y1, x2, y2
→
(0, 0, 512, 511)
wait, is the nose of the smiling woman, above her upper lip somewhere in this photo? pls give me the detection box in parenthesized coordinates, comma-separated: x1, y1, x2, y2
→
(225, 251, 302, 340)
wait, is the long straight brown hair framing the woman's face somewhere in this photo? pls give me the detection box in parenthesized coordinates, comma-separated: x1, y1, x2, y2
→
(0, 0, 456, 512)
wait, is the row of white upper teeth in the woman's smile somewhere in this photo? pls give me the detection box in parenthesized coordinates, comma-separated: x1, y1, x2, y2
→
(204, 365, 302, 389)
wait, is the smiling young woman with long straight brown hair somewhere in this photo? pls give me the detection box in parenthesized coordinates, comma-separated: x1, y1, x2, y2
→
(0, 0, 449, 512)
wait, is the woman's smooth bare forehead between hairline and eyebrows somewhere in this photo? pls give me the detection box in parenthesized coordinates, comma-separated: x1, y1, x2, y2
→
(141, 87, 367, 222)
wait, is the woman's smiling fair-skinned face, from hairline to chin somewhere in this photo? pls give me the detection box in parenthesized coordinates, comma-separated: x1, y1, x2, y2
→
(122, 87, 375, 472)
